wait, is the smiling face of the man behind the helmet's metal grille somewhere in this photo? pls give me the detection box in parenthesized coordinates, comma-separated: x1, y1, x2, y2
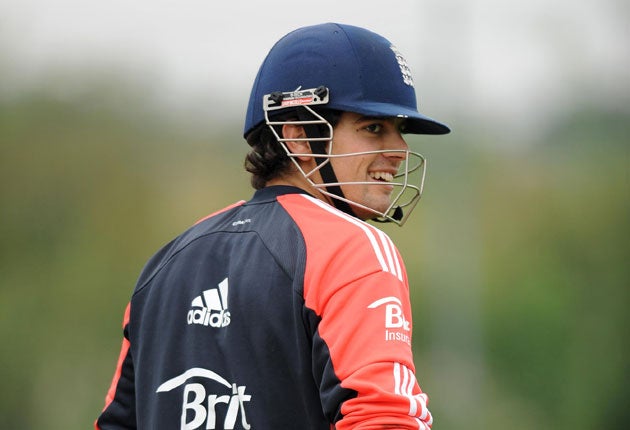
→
(331, 112, 408, 219)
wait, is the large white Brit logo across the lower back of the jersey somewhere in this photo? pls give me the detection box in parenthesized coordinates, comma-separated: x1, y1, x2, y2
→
(155, 367, 252, 430)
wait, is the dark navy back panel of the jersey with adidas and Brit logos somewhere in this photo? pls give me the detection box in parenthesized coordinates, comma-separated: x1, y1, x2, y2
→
(129, 187, 329, 429)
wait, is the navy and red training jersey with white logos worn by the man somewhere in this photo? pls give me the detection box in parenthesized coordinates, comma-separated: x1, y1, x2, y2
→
(95, 186, 432, 430)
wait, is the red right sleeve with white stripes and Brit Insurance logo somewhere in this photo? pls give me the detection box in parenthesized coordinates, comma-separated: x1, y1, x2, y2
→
(287, 196, 432, 430)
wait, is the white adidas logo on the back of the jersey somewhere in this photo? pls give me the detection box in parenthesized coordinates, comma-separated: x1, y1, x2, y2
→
(188, 278, 230, 327)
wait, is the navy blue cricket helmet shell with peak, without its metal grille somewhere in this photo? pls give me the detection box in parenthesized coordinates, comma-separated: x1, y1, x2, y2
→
(244, 23, 450, 137)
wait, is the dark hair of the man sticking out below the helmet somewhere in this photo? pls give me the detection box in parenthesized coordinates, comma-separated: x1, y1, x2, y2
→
(244, 109, 341, 190)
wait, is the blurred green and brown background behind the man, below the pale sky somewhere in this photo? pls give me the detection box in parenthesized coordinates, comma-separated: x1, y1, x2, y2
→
(0, 1, 630, 430)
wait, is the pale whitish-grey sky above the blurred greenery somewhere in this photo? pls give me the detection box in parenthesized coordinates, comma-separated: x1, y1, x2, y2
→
(0, 0, 630, 138)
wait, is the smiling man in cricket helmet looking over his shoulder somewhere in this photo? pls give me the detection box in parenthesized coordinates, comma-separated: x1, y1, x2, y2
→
(96, 23, 449, 430)
